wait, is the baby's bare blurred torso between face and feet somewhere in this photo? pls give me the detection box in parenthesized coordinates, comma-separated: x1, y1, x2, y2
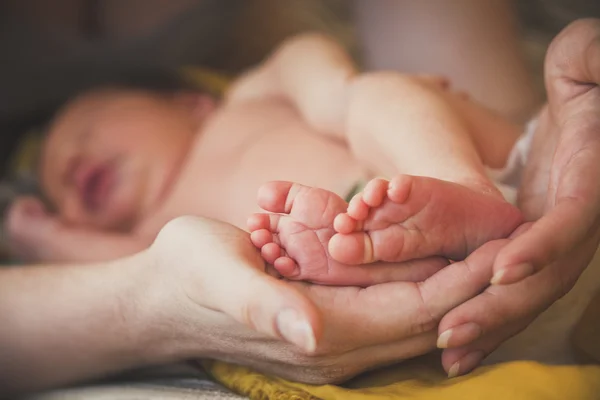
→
(142, 99, 369, 231)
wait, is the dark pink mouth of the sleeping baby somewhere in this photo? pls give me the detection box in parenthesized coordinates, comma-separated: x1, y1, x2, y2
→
(76, 163, 115, 212)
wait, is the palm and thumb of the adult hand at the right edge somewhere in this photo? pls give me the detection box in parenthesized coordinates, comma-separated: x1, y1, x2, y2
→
(495, 41, 600, 276)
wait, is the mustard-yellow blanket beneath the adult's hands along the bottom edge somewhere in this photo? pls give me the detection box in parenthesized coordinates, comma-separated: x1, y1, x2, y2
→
(206, 358, 600, 400)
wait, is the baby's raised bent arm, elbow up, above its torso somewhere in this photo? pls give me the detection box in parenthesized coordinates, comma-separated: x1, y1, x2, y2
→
(226, 34, 356, 140)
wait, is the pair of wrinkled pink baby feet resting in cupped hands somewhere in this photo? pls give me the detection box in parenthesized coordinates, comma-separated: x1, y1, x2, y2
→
(248, 175, 522, 286)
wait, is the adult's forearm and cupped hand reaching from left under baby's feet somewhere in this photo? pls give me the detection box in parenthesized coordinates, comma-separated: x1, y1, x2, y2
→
(0, 217, 497, 397)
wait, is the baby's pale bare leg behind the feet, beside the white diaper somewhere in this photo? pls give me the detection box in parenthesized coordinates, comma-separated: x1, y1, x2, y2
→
(347, 73, 492, 183)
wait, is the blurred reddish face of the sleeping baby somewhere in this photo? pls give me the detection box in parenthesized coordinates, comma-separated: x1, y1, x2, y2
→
(40, 90, 213, 230)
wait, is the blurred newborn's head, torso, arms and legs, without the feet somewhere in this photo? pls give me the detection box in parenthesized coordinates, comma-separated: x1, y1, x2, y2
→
(8, 35, 519, 268)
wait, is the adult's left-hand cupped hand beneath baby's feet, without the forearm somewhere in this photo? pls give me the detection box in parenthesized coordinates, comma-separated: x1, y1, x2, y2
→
(147, 217, 503, 383)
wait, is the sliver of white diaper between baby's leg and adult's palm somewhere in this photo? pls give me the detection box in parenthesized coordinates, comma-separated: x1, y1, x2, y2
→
(486, 119, 537, 205)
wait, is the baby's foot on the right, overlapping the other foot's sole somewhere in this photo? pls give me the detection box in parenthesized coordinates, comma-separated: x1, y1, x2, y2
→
(329, 175, 523, 264)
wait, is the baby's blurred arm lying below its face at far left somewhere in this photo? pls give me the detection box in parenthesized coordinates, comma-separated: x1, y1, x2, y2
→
(6, 198, 153, 262)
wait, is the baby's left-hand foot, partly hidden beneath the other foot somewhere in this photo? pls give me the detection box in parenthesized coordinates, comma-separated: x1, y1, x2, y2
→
(248, 182, 447, 286)
